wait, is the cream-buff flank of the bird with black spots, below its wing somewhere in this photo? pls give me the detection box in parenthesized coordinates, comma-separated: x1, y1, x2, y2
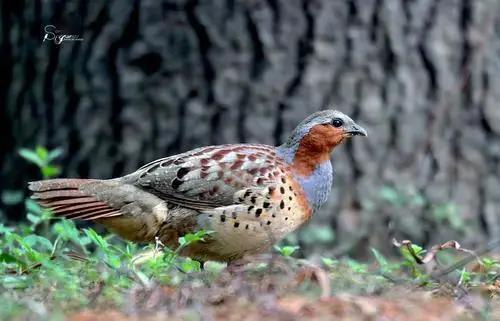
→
(198, 170, 311, 256)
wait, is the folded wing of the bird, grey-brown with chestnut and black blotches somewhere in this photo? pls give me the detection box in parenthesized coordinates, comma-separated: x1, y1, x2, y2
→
(124, 144, 284, 210)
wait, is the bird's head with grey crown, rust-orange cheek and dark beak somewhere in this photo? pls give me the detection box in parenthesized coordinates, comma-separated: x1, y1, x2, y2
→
(280, 110, 367, 175)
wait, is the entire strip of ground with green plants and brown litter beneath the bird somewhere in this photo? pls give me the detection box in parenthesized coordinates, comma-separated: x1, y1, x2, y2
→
(0, 195, 500, 321)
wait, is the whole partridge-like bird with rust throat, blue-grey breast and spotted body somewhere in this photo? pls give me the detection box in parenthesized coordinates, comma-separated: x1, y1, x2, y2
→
(28, 109, 367, 262)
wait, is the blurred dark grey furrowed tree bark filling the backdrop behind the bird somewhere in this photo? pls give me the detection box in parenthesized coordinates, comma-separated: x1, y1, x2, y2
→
(0, 0, 500, 257)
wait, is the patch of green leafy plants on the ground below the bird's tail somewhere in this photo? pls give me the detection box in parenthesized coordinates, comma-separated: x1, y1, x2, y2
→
(0, 204, 218, 316)
